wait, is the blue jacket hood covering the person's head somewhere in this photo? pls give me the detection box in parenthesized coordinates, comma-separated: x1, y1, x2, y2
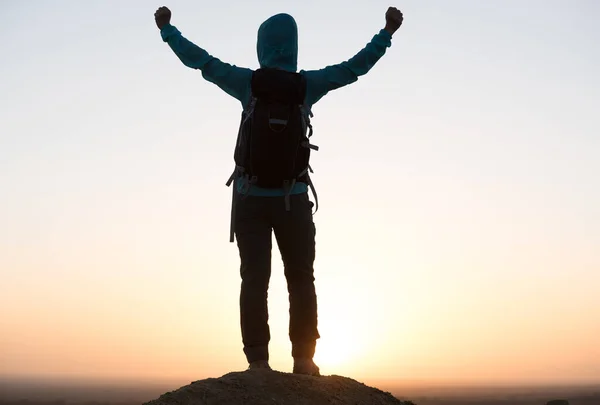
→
(256, 13, 298, 72)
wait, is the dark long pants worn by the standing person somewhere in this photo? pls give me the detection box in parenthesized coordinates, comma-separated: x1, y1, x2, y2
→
(234, 193, 320, 362)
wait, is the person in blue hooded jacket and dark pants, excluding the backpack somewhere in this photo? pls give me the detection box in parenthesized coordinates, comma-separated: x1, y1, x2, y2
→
(154, 6, 403, 376)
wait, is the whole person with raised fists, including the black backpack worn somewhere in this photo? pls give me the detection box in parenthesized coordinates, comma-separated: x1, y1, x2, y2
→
(155, 7, 403, 375)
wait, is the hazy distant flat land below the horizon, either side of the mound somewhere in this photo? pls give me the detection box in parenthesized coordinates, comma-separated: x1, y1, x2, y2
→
(0, 379, 600, 405)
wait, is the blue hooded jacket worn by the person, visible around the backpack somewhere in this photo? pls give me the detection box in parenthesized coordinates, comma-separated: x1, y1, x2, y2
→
(160, 14, 392, 196)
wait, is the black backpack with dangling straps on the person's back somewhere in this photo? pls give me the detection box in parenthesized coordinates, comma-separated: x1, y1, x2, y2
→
(227, 68, 319, 241)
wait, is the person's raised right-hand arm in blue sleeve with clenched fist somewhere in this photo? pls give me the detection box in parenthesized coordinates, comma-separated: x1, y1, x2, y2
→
(304, 7, 404, 105)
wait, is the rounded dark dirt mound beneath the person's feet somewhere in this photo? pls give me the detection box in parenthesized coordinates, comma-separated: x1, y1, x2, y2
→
(143, 370, 410, 405)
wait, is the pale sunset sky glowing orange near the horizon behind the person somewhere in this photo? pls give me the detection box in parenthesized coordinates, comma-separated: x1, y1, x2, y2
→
(0, 0, 600, 382)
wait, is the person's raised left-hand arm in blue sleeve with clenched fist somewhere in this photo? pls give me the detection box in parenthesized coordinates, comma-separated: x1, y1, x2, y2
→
(154, 7, 252, 104)
